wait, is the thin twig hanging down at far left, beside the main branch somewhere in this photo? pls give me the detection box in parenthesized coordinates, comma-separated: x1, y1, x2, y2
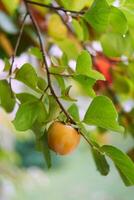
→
(9, 13, 28, 83)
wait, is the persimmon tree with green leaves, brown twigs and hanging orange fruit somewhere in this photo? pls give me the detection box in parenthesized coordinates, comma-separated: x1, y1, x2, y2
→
(0, 0, 134, 186)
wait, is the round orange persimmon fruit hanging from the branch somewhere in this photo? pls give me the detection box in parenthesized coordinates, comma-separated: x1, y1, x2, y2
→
(48, 121, 80, 155)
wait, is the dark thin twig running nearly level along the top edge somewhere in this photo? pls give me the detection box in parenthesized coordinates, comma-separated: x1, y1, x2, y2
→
(25, 0, 85, 15)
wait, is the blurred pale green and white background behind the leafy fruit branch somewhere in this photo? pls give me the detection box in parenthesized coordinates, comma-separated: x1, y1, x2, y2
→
(0, 0, 134, 200)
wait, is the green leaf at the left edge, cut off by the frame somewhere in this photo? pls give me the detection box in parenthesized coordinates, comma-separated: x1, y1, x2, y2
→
(0, 80, 15, 112)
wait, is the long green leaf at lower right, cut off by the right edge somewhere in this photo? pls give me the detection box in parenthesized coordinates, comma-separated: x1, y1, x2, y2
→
(101, 145, 134, 185)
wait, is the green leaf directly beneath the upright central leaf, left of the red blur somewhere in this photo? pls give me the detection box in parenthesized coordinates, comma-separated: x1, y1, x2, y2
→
(73, 75, 96, 97)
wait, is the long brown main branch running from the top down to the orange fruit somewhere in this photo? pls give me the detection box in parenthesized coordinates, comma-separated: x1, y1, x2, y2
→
(24, 0, 76, 124)
